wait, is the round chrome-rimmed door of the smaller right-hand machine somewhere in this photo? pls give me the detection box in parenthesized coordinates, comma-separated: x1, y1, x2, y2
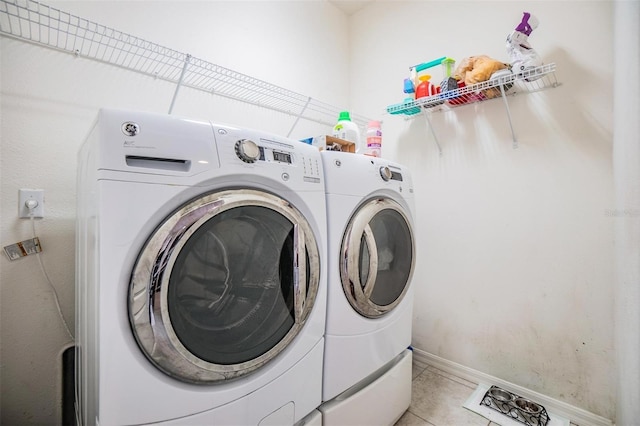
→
(340, 198, 415, 318)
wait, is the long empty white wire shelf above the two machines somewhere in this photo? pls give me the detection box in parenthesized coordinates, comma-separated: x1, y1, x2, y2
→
(0, 0, 369, 133)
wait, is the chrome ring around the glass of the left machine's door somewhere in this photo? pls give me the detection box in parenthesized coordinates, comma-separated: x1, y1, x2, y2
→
(129, 189, 320, 384)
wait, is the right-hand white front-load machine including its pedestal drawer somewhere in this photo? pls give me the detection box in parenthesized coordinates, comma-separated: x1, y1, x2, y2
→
(320, 152, 416, 425)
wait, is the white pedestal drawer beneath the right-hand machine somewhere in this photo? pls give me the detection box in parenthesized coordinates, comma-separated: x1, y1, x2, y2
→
(319, 349, 412, 426)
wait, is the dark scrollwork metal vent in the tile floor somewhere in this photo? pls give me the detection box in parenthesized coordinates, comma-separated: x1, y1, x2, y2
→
(480, 386, 549, 426)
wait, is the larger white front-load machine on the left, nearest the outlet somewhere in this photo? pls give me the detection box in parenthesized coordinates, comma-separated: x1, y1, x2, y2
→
(76, 110, 326, 425)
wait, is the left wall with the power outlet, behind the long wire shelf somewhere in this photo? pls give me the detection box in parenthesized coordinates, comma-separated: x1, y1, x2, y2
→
(0, 1, 348, 425)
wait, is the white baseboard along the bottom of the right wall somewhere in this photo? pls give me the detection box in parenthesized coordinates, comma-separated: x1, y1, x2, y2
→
(413, 348, 613, 426)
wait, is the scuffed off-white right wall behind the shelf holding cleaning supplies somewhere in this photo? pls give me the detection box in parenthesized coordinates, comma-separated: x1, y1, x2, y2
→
(350, 1, 616, 419)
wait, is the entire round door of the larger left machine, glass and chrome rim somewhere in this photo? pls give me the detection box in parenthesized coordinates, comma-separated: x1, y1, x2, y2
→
(129, 190, 320, 383)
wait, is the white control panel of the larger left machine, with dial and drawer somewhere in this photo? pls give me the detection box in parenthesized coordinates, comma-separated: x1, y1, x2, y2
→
(88, 109, 324, 191)
